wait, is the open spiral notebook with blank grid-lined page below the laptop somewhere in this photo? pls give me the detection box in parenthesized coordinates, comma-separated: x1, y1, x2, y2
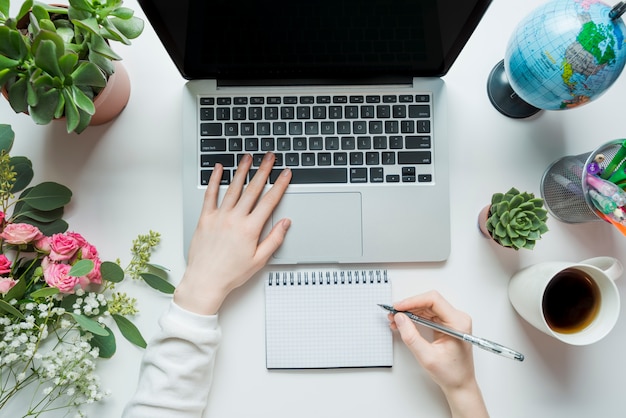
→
(265, 270, 393, 369)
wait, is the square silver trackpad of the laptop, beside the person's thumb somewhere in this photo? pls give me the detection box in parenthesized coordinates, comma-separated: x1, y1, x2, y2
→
(272, 193, 363, 262)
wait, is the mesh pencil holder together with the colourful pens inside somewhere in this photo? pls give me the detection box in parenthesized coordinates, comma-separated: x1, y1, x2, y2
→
(541, 139, 626, 232)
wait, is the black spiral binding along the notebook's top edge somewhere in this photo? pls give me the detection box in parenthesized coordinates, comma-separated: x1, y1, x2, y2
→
(268, 270, 389, 286)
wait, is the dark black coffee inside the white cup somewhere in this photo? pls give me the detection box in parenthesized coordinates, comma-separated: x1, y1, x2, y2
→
(542, 269, 600, 334)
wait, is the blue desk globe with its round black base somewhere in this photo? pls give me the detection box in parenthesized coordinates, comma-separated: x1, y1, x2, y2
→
(487, 0, 626, 118)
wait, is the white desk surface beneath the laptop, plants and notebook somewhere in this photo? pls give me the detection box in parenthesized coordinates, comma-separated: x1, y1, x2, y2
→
(0, 0, 626, 418)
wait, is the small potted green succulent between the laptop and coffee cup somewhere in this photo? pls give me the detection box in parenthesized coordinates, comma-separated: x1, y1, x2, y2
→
(478, 187, 548, 250)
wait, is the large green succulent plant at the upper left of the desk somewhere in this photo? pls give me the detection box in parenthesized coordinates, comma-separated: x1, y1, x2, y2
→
(0, 0, 144, 133)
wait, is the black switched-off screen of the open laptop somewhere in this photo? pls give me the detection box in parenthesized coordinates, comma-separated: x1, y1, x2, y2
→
(139, 0, 491, 80)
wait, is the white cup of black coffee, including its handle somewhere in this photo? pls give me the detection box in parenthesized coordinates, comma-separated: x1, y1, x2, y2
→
(509, 257, 624, 345)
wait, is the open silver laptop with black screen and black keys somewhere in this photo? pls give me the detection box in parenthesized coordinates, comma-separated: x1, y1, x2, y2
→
(139, 0, 490, 264)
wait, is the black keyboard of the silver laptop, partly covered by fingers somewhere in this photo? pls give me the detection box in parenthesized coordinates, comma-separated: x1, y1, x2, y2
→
(199, 94, 434, 185)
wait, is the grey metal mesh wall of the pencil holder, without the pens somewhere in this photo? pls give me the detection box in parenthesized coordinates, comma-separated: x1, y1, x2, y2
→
(541, 139, 624, 223)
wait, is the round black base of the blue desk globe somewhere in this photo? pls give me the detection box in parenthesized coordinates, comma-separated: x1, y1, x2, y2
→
(487, 60, 541, 119)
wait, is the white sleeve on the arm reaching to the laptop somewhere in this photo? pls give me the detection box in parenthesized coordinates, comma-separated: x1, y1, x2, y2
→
(123, 302, 221, 418)
